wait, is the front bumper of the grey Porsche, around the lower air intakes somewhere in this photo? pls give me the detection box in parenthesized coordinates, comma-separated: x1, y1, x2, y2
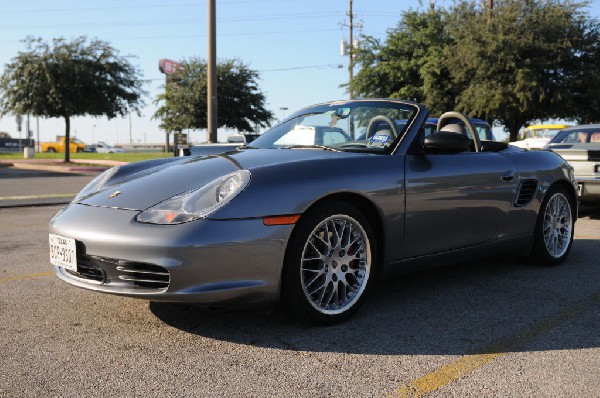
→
(50, 204, 293, 306)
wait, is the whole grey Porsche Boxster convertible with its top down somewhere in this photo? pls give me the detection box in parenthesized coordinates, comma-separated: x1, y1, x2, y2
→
(49, 100, 577, 323)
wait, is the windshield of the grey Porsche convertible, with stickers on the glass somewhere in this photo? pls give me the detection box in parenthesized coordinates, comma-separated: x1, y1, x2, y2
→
(250, 101, 418, 153)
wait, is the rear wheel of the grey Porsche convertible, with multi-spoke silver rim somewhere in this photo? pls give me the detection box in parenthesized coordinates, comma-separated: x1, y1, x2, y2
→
(530, 186, 575, 266)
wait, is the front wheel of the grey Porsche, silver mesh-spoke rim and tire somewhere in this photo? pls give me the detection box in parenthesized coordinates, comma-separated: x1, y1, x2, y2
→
(282, 201, 377, 325)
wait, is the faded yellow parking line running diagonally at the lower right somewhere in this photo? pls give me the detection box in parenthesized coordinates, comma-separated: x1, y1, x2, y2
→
(390, 293, 600, 397)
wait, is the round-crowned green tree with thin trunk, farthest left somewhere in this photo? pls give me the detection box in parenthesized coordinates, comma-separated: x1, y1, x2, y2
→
(0, 37, 144, 162)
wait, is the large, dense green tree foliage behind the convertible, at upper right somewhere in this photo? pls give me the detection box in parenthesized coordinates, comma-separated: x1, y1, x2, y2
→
(351, 0, 600, 141)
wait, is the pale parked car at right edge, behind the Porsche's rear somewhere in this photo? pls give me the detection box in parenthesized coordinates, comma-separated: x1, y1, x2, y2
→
(545, 124, 600, 202)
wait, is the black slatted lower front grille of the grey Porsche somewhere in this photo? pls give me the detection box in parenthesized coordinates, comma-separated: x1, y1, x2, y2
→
(67, 254, 170, 290)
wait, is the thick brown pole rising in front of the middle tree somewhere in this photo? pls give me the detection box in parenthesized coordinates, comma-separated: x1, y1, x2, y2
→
(206, 0, 218, 143)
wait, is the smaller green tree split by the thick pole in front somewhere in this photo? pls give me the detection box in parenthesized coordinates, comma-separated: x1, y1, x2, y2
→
(154, 58, 273, 139)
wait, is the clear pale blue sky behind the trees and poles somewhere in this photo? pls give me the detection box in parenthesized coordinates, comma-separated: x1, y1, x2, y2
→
(0, 0, 600, 143)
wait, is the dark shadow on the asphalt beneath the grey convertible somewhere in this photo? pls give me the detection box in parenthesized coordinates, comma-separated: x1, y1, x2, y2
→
(150, 240, 600, 355)
